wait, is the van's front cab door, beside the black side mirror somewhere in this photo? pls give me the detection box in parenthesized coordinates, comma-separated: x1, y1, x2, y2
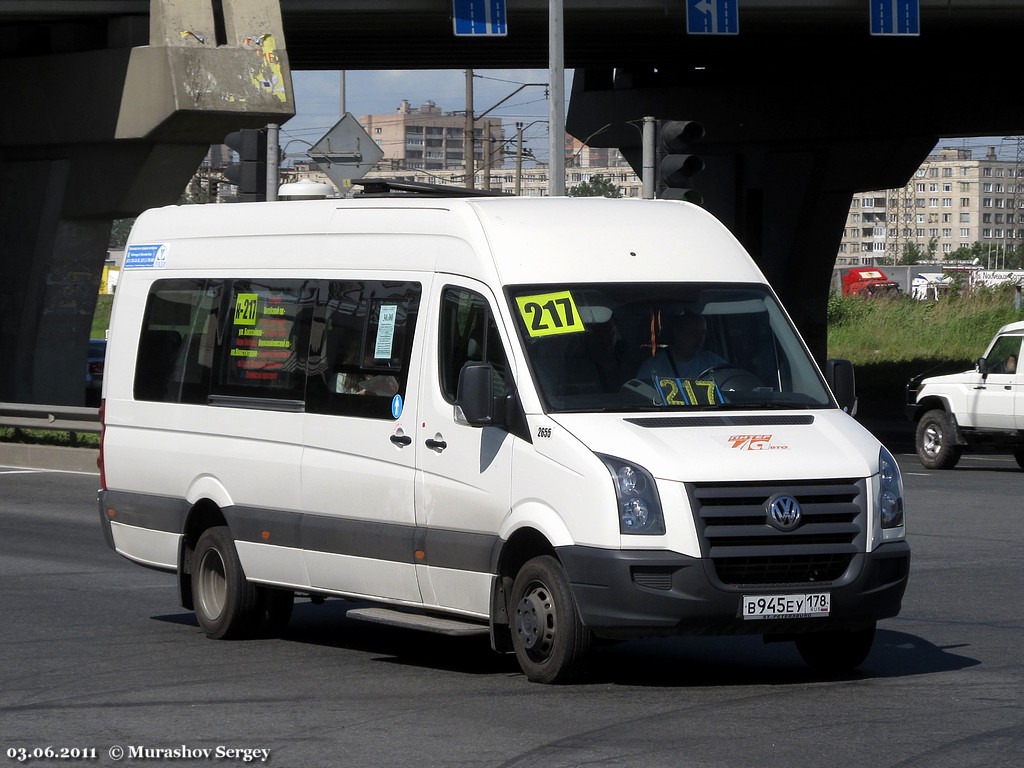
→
(416, 278, 517, 616)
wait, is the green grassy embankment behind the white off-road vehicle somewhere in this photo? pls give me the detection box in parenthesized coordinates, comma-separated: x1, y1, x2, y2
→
(828, 286, 1024, 416)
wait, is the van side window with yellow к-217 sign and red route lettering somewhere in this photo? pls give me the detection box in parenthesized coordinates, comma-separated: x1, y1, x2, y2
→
(211, 280, 316, 401)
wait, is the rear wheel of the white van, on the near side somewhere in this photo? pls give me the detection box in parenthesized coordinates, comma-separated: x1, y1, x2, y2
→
(191, 525, 265, 640)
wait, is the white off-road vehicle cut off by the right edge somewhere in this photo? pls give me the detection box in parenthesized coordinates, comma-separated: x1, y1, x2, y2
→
(906, 322, 1024, 469)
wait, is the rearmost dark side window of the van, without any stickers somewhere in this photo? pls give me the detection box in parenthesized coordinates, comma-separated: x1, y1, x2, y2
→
(134, 280, 221, 402)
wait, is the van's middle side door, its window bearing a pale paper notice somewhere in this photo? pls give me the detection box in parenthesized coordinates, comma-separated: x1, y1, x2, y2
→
(301, 274, 423, 603)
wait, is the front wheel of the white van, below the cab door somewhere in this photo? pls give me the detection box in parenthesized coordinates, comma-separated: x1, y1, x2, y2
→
(509, 555, 591, 683)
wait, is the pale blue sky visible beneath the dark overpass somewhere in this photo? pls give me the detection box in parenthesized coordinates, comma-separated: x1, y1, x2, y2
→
(280, 70, 1017, 167)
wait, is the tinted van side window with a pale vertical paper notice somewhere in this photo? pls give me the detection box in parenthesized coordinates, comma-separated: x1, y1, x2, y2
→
(306, 281, 422, 419)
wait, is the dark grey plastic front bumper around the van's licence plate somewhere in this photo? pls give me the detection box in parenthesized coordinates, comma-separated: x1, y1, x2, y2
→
(557, 542, 910, 638)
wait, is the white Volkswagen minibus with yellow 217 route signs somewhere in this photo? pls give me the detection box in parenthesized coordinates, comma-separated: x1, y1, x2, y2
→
(98, 197, 909, 682)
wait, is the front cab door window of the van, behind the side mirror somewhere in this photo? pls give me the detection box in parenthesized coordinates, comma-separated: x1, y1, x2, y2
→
(438, 287, 508, 402)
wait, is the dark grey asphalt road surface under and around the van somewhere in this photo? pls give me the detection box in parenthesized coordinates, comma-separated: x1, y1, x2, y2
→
(0, 455, 1024, 768)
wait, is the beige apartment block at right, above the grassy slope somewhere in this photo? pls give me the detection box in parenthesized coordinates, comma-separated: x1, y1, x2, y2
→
(836, 146, 1024, 267)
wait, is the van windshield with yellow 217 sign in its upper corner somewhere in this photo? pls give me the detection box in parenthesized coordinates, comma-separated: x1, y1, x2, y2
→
(508, 283, 833, 413)
